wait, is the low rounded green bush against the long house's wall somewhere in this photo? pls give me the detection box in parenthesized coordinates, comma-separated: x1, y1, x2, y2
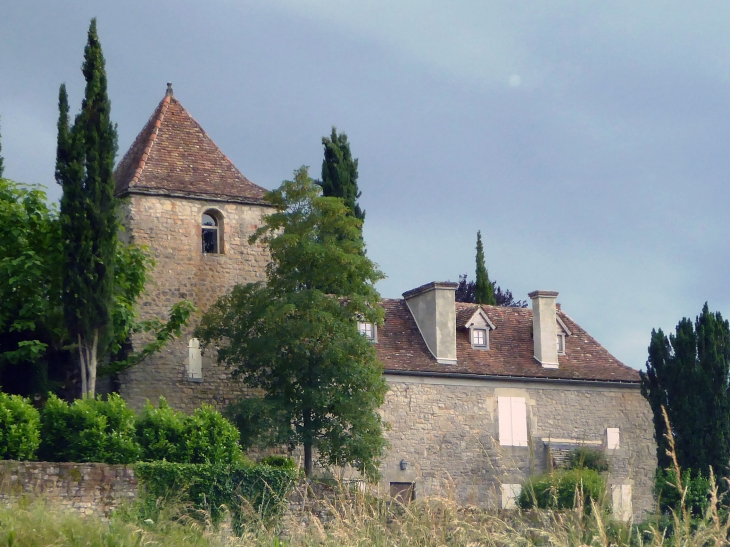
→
(517, 469, 606, 511)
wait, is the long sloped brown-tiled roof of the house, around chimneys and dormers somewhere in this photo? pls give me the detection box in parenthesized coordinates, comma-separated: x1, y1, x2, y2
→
(376, 299, 640, 383)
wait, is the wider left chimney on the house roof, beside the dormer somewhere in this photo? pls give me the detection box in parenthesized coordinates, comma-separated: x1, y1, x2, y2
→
(403, 281, 456, 365)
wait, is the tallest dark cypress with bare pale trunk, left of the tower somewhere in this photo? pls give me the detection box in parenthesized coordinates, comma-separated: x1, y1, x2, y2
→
(56, 19, 118, 397)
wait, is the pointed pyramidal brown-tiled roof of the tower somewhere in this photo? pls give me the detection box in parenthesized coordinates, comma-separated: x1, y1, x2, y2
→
(114, 84, 266, 203)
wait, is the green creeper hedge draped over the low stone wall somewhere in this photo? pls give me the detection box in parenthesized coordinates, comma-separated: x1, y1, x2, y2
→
(135, 461, 299, 529)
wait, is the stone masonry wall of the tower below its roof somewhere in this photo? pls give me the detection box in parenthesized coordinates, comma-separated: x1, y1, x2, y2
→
(118, 195, 271, 412)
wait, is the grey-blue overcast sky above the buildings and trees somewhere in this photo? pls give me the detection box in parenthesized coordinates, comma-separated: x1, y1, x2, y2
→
(0, 0, 730, 368)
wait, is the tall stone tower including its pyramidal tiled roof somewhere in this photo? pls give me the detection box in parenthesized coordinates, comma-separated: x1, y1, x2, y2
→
(115, 84, 272, 412)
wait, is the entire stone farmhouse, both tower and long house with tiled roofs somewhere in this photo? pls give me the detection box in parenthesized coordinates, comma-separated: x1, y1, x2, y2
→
(115, 84, 656, 519)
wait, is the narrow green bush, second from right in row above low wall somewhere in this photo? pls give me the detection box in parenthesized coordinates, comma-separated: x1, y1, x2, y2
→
(137, 397, 187, 463)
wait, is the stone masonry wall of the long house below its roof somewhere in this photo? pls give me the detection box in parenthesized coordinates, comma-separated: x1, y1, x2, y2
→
(381, 375, 656, 518)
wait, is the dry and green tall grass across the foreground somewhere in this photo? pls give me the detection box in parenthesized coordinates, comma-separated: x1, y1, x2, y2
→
(0, 484, 729, 547)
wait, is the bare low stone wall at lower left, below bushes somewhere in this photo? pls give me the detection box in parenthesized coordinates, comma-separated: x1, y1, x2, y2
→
(0, 461, 137, 516)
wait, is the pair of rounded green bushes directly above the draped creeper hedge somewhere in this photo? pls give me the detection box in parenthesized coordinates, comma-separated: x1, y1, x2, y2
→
(137, 397, 244, 464)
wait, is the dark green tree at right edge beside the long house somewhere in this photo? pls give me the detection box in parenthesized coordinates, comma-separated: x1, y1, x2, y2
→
(640, 303, 730, 484)
